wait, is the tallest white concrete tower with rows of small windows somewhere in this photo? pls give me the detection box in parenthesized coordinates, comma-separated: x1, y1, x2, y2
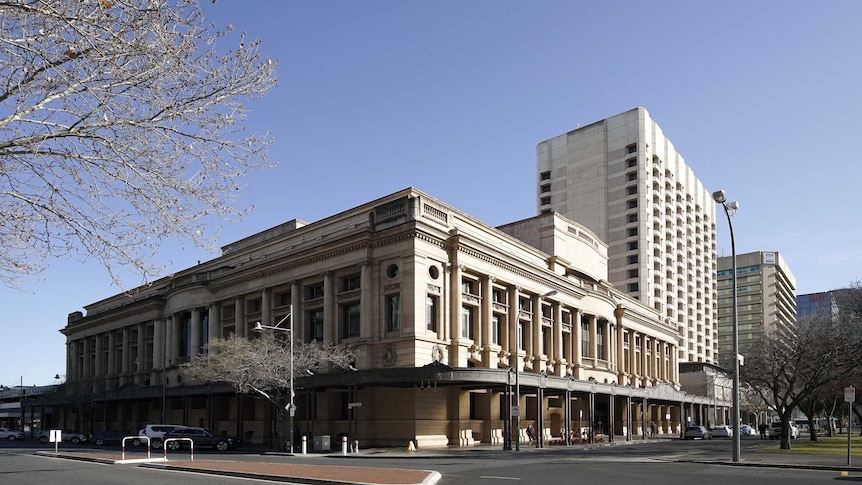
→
(536, 108, 718, 362)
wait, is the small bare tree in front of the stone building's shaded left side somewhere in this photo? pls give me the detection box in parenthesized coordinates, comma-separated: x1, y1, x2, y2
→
(182, 333, 354, 449)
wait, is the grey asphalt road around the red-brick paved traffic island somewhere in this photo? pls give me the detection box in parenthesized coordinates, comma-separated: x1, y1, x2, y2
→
(0, 438, 862, 485)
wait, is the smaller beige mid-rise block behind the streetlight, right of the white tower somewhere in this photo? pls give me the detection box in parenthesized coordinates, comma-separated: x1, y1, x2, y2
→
(718, 251, 796, 365)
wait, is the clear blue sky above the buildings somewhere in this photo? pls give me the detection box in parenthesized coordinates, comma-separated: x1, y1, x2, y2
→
(0, 0, 862, 385)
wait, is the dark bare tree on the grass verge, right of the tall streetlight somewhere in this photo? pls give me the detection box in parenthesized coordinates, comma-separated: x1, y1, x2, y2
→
(740, 313, 860, 449)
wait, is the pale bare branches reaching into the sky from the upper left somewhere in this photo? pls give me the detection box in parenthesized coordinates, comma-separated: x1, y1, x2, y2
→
(0, 0, 276, 287)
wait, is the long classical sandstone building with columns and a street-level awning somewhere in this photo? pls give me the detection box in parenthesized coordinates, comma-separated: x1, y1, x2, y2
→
(47, 189, 706, 446)
